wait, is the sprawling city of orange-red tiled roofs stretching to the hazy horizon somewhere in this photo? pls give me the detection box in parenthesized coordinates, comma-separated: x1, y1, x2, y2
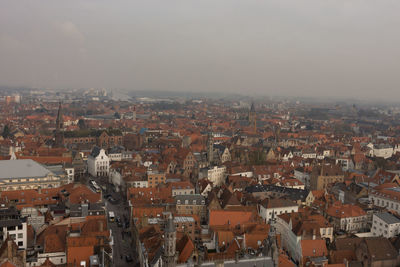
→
(0, 88, 400, 267)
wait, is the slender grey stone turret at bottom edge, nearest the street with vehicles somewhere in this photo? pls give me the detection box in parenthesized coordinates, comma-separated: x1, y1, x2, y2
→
(163, 214, 176, 267)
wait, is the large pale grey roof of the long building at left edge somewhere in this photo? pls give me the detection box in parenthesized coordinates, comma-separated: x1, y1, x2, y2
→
(0, 159, 51, 180)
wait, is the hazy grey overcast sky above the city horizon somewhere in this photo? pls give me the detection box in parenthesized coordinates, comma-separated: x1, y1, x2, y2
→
(0, 0, 400, 99)
